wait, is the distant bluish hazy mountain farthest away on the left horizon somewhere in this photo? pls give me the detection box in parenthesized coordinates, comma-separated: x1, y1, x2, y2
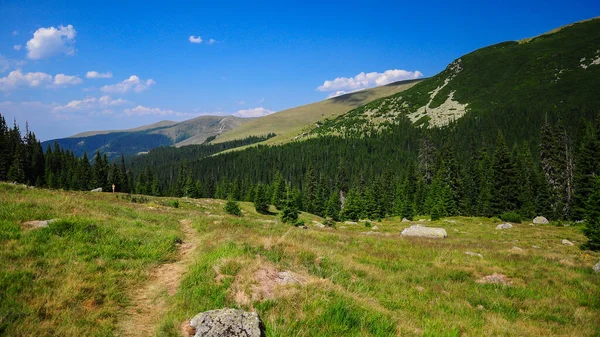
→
(42, 116, 252, 157)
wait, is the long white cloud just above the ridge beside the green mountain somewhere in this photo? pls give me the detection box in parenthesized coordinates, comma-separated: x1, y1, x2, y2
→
(317, 69, 423, 93)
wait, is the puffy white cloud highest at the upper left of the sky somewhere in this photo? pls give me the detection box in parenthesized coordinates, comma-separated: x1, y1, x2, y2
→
(26, 25, 77, 60)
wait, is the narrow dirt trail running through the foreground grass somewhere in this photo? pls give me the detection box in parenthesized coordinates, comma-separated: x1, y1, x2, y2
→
(119, 220, 200, 336)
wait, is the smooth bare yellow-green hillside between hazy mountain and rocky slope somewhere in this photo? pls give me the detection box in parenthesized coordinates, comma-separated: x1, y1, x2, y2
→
(213, 80, 420, 144)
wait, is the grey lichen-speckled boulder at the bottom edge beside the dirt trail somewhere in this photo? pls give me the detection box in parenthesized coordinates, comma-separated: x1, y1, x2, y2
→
(190, 308, 265, 337)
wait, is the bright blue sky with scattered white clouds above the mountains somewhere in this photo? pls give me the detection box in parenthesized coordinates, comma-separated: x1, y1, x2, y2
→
(0, 0, 600, 140)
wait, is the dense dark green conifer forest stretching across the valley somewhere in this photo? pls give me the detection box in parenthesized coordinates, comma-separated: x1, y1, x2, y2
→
(0, 114, 600, 249)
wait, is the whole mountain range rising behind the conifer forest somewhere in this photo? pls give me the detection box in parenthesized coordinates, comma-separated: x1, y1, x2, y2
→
(46, 18, 600, 156)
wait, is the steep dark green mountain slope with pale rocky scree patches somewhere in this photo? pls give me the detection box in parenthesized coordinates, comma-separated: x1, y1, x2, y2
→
(313, 19, 600, 135)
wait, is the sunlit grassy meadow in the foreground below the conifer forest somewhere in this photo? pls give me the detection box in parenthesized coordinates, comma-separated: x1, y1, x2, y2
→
(0, 184, 600, 336)
